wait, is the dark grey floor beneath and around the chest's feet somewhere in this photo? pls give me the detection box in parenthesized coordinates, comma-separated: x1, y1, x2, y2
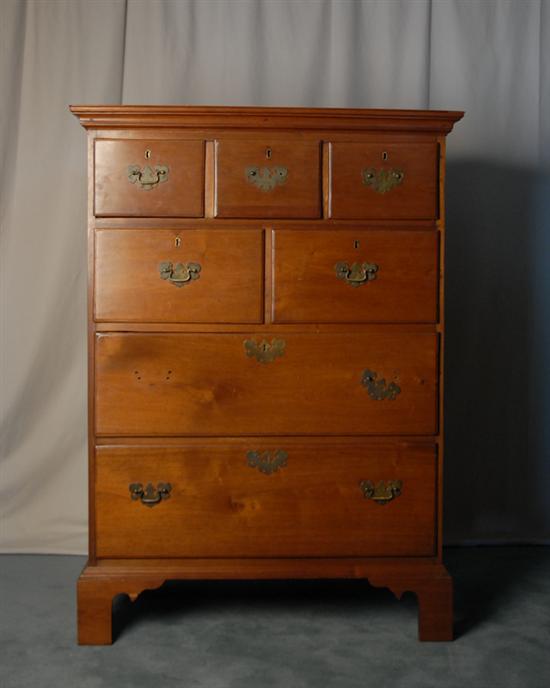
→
(0, 547, 550, 688)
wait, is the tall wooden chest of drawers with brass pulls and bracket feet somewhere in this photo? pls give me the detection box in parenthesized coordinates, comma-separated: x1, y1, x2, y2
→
(71, 106, 462, 644)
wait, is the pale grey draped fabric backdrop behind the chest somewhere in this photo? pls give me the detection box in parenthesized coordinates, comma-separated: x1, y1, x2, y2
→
(0, 0, 550, 553)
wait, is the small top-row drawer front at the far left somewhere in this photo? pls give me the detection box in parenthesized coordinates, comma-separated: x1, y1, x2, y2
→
(94, 139, 204, 217)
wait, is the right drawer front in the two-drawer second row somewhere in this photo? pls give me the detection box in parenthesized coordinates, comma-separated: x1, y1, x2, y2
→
(273, 230, 438, 323)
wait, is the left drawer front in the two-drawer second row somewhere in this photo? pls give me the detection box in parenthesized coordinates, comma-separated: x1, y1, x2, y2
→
(95, 229, 263, 323)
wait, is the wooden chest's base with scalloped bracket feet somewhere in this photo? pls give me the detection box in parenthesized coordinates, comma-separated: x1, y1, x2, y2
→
(77, 558, 453, 645)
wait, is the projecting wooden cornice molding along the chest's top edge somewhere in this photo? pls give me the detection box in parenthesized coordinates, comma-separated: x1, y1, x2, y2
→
(69, 105, 464, 134)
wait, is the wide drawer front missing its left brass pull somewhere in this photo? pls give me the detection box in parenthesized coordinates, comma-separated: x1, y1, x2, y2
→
(95, 332, 437, 436)
